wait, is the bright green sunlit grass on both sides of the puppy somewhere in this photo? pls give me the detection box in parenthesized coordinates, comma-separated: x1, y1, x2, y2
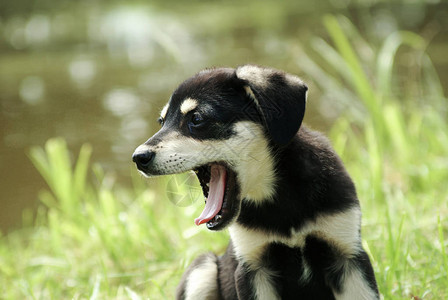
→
(0, 16, 448, 299)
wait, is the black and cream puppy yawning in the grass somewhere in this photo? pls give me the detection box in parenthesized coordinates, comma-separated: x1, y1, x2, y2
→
(133, 65, 379, 300)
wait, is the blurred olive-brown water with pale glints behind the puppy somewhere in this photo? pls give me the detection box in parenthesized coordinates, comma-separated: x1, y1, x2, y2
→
(0, 0, 448, 231)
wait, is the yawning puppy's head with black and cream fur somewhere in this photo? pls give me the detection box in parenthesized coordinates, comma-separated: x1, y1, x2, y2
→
(133, 65, 307, 230)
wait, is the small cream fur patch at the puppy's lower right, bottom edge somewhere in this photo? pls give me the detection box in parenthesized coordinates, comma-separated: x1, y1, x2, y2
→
(334, 268, 378, 300)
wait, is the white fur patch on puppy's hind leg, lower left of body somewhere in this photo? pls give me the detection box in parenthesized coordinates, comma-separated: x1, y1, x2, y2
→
(185, 257, 219, 300)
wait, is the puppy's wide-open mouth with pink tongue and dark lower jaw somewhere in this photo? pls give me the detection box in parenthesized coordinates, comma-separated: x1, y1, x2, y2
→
(194, 163, 239, 230)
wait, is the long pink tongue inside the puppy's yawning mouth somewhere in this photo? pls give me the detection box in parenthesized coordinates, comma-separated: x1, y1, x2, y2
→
(194, 165, 226, 225)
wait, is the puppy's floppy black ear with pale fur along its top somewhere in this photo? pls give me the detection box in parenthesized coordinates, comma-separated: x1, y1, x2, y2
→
(236, 65, 308, 145)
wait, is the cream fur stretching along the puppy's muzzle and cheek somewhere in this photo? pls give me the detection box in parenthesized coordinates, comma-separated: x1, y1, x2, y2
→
(145, 121, 276, 203)
